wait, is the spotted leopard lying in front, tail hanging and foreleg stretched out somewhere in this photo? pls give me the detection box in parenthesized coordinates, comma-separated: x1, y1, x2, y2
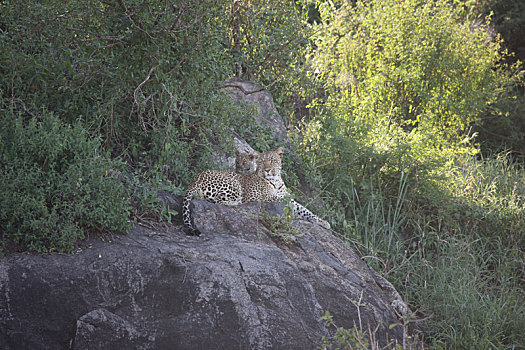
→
(182, 147, 330, 235)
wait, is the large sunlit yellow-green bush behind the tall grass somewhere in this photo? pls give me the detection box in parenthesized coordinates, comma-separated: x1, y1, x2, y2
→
(298, 0, 522, 235)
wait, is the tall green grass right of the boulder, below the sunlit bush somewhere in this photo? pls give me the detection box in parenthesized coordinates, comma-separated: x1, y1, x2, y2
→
(334, 156, 525, 349)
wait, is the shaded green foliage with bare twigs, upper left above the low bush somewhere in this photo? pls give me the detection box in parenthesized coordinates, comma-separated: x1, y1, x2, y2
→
(0, 0, 255, 183)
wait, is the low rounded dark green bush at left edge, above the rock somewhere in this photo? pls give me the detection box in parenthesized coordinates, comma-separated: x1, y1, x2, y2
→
(0, 113, 130, 252)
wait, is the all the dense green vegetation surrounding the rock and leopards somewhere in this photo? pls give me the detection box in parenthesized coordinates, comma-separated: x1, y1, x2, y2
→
(0, 0, 525, 349)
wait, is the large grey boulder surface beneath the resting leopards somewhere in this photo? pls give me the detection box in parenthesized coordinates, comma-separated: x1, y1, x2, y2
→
(0, 200, 403, 350)
